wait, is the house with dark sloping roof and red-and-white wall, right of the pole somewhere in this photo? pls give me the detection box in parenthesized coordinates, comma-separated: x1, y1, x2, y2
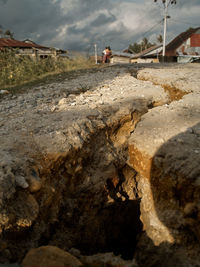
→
(165, 27, 200, 63)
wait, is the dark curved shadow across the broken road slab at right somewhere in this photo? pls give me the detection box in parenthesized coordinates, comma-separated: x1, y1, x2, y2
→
(135, 123, 200, 267)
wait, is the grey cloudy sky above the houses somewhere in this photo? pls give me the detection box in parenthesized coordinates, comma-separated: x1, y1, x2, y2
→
(0, 0, 200, 52)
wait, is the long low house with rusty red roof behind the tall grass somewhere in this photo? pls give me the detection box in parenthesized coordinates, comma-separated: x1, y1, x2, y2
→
(0, 38, 64, 58)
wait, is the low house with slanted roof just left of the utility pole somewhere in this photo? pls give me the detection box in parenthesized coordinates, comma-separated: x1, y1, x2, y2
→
(130, 44, 162, 63)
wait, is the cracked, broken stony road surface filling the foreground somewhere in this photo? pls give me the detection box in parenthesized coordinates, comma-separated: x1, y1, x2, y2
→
(0, 64, 200, 267)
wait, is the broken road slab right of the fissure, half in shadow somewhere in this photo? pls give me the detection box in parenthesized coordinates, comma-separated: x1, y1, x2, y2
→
(128, 68, 200, 266)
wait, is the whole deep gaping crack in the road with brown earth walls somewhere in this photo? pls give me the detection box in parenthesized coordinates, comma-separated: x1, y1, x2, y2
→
(0, 96, 148, 261)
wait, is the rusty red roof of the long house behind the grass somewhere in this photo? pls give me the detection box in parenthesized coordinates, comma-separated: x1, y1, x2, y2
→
(0, 38, 46, 48)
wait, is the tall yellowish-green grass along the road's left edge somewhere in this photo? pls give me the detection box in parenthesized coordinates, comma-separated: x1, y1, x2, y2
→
(0, 50, 94, 88)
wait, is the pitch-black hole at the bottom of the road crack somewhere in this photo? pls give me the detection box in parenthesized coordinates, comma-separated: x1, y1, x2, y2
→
(76, 200, 142, 260)
